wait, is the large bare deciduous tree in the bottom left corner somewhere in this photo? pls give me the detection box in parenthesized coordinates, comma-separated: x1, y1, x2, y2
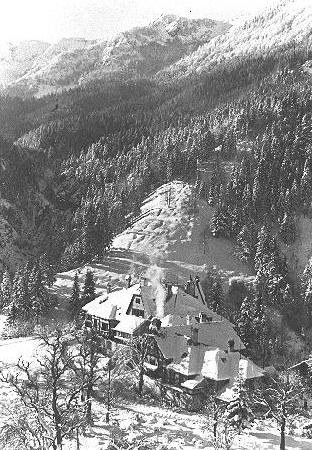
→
(1, 330, 85, 450)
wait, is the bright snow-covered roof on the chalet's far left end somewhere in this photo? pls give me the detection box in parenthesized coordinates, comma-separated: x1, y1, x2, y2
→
(82, 284, 140, 320)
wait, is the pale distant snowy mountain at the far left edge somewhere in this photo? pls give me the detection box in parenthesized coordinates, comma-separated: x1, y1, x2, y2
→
(0, 41, 49, 87)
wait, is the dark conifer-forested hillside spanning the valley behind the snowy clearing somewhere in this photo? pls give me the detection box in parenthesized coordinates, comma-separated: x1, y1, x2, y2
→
(0, 1, 312, 342)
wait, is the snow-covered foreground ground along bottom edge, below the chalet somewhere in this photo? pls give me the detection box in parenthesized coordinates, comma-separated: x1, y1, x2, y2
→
(67, 403, 312, 450)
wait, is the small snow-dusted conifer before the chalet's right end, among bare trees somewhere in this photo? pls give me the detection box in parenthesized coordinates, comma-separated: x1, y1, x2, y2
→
(226, 371, 251, 434)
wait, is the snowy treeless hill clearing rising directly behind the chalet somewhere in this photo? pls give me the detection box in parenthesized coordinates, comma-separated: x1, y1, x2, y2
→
(53, 181, 253, 304)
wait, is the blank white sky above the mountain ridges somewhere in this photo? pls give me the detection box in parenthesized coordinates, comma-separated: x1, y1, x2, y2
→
(0, 0, 278, 42)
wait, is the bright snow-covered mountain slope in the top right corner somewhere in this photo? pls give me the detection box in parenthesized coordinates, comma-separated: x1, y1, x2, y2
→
(163, 0, 312, 79)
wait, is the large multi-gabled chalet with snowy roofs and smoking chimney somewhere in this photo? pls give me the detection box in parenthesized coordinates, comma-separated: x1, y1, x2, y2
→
(83, 272, 263, 409)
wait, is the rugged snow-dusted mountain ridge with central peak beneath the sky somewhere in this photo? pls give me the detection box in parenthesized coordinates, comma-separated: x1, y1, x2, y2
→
(3, 15, 230, 96)
